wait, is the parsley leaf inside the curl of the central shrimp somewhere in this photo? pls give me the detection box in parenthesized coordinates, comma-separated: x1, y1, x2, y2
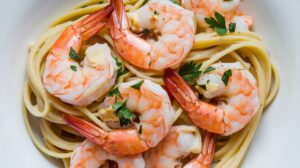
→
(112, 100, 136, 126)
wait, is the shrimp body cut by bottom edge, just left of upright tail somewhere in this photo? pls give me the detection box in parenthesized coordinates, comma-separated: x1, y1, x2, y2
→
(144, 125, 201, 168)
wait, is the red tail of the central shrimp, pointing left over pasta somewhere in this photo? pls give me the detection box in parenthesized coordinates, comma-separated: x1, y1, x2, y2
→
(62, 113, 107, 145)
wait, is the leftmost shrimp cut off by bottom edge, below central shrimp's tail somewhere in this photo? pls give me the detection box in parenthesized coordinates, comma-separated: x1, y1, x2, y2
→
(70, 140, 145, 168)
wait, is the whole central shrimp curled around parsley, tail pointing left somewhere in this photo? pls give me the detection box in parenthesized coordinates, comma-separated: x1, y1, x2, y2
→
(63, 79, 175, 155)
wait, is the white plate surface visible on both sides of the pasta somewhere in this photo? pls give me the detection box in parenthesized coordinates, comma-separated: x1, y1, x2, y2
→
(0, 0, 300, 168)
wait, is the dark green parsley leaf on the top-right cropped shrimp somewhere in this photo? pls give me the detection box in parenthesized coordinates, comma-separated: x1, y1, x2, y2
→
(204, 11, 235, 36)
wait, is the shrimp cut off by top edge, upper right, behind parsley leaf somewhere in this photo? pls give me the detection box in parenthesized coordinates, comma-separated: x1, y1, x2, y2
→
(181, 0, 253, 32)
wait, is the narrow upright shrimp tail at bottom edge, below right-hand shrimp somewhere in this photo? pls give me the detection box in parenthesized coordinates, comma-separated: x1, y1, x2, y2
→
(183, 133, 216, 168)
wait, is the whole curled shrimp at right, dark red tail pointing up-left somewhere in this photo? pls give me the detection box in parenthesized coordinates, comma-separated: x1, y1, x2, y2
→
(164, 63, 259, 136)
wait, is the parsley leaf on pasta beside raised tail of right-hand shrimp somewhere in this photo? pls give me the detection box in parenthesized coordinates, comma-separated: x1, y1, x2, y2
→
(179, 62, 202, 84)
